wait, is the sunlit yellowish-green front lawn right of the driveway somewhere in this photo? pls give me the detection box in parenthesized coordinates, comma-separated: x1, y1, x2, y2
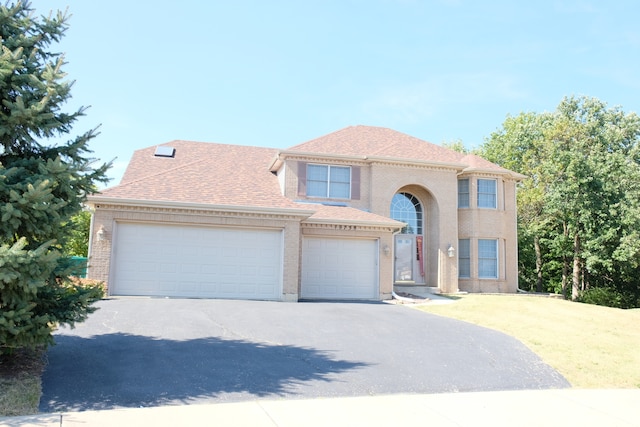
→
(416, 294, 640, 388)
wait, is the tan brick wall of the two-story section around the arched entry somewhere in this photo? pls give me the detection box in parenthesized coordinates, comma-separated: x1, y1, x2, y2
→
(284, 157, 518, 293)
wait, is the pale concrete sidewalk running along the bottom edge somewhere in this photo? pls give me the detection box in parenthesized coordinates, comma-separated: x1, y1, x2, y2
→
(5, 389, 640, 427)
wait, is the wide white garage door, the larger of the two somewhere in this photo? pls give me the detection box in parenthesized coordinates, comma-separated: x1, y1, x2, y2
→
(111, 223, 282, 299)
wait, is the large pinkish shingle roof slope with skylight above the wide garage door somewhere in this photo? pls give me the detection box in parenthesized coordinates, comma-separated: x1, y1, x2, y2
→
(100, 141, 299, 208)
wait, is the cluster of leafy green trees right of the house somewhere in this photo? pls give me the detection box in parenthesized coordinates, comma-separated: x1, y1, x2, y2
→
(480, 97, 640, 307)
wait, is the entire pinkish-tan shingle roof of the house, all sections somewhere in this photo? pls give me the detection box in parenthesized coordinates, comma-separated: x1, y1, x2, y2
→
(95, 126, 517, 226)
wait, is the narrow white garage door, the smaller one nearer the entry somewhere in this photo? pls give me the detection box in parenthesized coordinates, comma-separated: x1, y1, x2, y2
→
(300, 237, 379, 299)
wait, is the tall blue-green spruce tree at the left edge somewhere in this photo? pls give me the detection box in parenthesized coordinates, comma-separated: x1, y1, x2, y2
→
(0, 1, 109, 355)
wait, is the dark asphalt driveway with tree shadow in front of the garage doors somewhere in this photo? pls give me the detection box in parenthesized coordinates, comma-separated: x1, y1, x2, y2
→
(40, 298, 569, 412)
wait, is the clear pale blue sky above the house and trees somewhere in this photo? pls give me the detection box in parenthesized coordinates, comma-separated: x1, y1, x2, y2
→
(46, 0, 640, 185)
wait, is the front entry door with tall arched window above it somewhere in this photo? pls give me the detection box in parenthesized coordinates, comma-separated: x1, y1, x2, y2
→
(391, 192, 425, 283)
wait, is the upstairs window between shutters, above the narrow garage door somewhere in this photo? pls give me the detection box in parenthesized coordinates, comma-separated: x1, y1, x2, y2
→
(307, 164, 351, 199)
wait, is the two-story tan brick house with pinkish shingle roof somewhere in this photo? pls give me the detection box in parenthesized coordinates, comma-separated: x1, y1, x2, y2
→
(88, 126, 524, 301)
